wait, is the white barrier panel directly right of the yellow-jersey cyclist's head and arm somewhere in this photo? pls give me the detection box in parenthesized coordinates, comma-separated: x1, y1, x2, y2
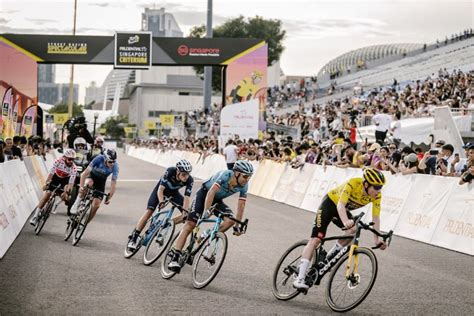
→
(380, 174, 415, 232)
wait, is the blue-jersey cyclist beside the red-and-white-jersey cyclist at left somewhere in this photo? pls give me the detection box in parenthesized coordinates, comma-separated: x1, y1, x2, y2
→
(71, 149, 119, 222)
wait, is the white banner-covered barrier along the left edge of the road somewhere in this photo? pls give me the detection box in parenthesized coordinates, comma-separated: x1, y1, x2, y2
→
(0, 152, 58, 259)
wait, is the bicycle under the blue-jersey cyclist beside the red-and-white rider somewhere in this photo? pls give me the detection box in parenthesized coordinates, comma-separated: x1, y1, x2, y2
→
(64, 188, 109, 246)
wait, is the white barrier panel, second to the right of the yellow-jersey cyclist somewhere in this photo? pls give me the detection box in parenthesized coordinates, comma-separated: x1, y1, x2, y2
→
(394, 175, 456, 243)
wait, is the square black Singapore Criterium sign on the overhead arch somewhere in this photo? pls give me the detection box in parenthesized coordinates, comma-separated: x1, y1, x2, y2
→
(114, 32, 152, 69)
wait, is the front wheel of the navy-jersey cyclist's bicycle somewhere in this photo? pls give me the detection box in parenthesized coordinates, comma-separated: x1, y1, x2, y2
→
(143, 220, 175, 266)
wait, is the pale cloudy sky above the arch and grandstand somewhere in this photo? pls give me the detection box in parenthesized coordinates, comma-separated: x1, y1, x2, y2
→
(0, 0, 474, 102)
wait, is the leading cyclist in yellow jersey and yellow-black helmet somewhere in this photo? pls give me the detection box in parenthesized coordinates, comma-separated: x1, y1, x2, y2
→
(293, 168, 387, 289)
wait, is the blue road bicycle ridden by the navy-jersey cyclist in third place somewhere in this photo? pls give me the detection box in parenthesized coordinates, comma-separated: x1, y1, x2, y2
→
(123, 198, 187, 266)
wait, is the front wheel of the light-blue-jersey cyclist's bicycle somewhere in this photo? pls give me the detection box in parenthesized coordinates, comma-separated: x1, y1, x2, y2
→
(193, 232, 227, 289)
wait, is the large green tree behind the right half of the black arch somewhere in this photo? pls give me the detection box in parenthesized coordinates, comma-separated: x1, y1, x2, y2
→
(189, 15, 286, 91)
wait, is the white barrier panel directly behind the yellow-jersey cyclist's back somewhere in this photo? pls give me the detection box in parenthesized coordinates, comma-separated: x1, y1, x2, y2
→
(301, 165, 337, 212)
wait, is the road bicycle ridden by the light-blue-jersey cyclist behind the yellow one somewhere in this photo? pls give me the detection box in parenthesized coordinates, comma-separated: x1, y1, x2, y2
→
(161, 205, 248, 289)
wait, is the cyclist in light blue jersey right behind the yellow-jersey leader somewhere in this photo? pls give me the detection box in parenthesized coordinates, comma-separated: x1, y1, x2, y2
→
(168, 160, 253, 272)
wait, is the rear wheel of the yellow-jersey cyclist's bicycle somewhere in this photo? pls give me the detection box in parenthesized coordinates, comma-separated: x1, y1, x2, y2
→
(272, 240, 308, 301)
